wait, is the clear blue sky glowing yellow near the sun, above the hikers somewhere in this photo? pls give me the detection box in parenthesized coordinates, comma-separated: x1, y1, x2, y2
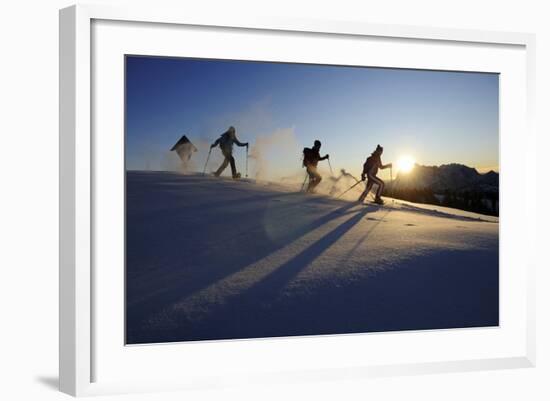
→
(126, 56, 499, 177)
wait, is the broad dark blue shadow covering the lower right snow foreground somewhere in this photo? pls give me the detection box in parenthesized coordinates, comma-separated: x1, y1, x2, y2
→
(157, 249, 499, 341)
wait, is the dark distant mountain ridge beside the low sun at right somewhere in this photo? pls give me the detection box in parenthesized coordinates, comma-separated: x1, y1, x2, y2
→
(393, 163, 499, 193)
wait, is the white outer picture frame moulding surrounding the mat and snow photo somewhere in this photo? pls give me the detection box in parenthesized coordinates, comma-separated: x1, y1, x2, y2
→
(59, 5, 536, 396)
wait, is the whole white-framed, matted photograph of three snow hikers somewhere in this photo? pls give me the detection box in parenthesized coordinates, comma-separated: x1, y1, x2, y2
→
(60, 6, 535, 395)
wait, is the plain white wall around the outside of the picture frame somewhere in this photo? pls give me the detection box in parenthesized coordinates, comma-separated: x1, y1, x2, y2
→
(0, 0, 550, 400)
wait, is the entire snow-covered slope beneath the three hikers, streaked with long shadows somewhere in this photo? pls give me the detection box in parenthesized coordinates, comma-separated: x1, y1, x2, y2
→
(127, 172, 499, 343)
